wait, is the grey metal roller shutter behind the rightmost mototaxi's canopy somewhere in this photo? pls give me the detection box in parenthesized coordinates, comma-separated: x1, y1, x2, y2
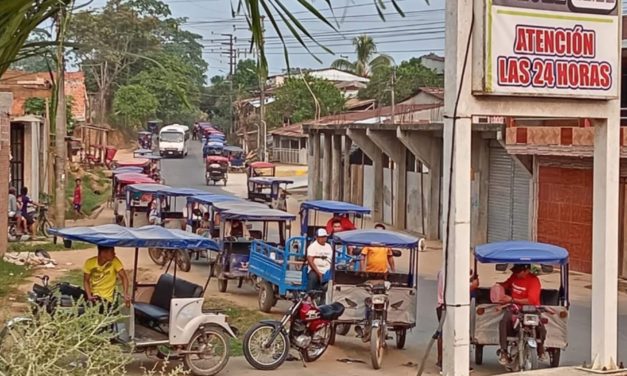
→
(488, 143, 531, 242)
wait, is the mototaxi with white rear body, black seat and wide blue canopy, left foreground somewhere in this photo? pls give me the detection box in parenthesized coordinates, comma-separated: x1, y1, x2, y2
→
(45, 225, 235, 376)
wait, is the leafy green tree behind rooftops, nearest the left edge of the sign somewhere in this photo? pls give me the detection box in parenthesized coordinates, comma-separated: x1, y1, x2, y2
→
(358, 58, 444, 105)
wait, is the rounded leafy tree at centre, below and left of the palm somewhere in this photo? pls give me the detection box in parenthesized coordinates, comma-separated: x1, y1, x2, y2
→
(266, 75, 345, 128)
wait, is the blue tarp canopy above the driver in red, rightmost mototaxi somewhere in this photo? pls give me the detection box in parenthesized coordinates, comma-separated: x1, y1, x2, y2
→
(475, 240, 568, 264)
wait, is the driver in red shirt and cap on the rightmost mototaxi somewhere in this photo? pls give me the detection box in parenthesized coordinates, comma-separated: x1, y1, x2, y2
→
(499, 264, 546, 364)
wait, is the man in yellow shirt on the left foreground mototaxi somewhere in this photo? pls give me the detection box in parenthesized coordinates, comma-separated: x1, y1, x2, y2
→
(83, 246, 131, 306)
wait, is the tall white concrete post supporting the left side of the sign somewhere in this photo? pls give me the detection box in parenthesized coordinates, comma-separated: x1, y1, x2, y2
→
(442, 0, 473, 376)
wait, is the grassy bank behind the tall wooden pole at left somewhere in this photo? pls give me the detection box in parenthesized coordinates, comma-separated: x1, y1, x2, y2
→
(65, 169, 111, 218)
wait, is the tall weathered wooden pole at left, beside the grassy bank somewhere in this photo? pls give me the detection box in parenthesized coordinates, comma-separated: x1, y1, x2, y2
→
(55, 7, 67, 228)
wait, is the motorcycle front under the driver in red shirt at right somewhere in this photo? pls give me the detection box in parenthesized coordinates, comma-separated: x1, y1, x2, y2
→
(497, 304, 548, 372)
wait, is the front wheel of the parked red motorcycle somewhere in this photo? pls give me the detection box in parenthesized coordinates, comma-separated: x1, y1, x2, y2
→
(243, 322, 290, 371)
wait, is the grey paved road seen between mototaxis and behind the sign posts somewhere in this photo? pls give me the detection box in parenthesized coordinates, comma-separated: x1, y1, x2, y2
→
(162, 141, 627, 374)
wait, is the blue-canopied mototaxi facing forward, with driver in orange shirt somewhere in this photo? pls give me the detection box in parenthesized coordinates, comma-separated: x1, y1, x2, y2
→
(327, 230, 419, 369)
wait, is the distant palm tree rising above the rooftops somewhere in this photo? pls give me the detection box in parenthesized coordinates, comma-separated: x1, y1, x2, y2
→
(331, 35, 392, 77)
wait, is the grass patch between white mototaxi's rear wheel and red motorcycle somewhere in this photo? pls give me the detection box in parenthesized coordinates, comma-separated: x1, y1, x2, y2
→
(203, 297, 272, 356)
